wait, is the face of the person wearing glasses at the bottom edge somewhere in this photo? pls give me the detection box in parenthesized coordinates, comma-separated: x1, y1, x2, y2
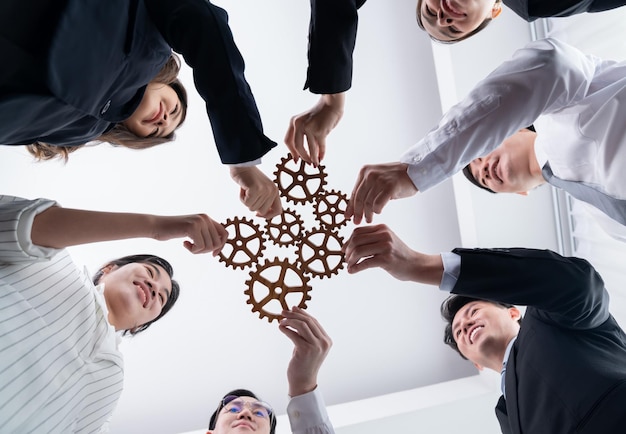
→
(208, 396, 270, 434)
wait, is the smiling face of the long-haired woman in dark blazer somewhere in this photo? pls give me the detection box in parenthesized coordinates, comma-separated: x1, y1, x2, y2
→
(123, 83, 183, 138)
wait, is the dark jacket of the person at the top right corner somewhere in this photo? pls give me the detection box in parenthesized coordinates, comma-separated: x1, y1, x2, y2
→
(503, 0, 626, 21)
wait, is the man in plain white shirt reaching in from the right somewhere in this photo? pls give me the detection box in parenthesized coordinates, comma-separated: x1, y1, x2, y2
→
(346, 39, 626, 238)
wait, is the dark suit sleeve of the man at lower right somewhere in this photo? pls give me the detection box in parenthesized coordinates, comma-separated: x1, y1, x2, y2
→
(452, 248, 609, 329)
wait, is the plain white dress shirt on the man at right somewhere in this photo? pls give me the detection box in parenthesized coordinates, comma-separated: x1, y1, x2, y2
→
(401, 39, 626, 231)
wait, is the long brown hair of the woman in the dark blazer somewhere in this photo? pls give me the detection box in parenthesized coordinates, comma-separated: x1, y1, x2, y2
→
(26, 53, 187, 161)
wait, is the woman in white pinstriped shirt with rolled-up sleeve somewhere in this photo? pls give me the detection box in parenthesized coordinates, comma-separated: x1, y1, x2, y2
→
(0, 196, 226, 433)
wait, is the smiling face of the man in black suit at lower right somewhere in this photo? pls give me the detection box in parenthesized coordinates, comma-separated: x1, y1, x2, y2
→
(452, 301, 521, 372)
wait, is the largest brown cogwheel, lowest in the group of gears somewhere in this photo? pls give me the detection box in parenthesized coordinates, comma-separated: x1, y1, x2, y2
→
(244, 258, 312, 322)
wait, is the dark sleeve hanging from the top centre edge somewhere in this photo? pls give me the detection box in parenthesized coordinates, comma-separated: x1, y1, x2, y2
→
(304, 0, 365, 94)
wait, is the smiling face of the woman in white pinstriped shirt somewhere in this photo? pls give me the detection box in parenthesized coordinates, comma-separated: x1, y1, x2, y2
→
(99, 262, 172, 330)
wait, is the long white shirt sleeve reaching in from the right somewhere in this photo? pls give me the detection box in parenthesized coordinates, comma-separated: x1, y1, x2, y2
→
(400, 39, 597, 192)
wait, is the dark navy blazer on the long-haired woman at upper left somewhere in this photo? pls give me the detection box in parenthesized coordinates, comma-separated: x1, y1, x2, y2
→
(0, 0, 276, 163)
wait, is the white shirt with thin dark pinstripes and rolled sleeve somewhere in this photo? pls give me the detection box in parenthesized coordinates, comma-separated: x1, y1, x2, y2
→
(0, 196, 123, 433)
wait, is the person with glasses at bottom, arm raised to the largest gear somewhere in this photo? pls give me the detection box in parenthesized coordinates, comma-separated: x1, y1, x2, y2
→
(207, 307, 335, 434)
